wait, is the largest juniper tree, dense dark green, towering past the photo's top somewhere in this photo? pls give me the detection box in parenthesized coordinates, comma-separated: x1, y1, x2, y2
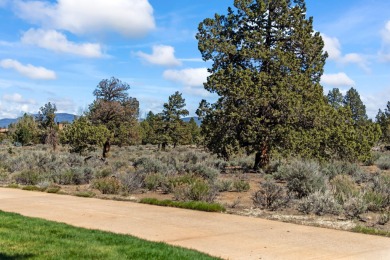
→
(196, 0, 327, 168)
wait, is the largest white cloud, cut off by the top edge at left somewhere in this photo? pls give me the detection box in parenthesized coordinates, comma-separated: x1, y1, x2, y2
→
(15, 0, 155, 37)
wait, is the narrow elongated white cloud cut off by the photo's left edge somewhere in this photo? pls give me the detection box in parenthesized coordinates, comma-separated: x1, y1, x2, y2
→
(0, 59, 56, 80)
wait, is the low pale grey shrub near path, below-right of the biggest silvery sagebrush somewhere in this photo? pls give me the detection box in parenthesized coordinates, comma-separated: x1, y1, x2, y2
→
(298, 190, 341, 216)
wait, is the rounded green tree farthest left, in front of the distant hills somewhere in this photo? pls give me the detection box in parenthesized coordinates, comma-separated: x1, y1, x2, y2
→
(9, 114, 40, 145)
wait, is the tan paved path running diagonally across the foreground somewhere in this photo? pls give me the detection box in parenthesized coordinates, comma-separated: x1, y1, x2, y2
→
(0, 188, 390, 260)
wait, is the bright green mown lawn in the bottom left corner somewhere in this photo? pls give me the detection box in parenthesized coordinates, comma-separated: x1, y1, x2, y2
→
(0, 211, 217, 260)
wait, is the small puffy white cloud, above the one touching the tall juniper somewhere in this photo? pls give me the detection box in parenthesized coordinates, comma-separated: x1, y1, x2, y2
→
(137, 45, 181, 66)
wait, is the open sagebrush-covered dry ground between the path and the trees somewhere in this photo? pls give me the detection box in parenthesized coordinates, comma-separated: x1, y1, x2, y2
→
(0, 145, 390, 234)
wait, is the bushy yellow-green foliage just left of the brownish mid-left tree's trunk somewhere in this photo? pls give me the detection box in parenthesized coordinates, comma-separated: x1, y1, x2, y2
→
(61, 117, 110, 154)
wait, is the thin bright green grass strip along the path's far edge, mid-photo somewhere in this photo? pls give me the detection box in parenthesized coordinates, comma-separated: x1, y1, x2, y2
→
(140, 198, 226, 212)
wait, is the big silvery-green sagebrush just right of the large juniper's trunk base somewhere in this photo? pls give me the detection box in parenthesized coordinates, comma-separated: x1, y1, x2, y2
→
(277, 160, 325, 198)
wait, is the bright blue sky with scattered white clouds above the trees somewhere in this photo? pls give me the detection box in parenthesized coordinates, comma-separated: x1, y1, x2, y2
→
(0, 0, 390, 118)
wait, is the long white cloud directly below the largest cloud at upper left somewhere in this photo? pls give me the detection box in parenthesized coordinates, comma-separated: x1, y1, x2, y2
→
(22, 29, 103, 58)
